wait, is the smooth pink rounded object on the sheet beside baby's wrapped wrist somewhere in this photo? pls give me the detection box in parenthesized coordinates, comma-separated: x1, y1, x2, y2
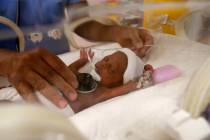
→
(152, 65, 182, 84)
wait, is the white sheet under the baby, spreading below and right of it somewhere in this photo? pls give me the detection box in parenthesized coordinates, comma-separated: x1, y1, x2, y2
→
(70, 34, 210, 140)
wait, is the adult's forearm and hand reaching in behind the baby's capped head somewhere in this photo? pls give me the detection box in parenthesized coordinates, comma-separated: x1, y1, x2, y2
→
(75, 21, 154, 58)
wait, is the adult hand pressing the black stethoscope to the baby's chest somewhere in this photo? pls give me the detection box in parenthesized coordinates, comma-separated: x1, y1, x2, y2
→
(2, 48, 78, 108)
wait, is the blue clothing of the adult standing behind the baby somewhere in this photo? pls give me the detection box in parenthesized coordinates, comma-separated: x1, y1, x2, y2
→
(0, 0, 79, 54)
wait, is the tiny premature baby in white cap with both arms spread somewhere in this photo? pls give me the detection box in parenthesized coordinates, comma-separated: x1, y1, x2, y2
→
(69, 48, 153, 112)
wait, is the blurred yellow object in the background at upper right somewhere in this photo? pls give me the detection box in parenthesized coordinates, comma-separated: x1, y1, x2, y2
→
(144, 0, 188, 35)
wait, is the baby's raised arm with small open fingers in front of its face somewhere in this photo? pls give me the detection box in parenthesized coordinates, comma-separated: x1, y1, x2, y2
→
(69, 49, 94, 75)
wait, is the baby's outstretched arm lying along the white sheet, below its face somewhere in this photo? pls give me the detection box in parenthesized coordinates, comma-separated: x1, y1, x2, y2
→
(69, 81, 137, 112)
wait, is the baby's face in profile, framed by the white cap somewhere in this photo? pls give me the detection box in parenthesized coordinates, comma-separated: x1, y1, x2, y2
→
(95, 51, 128, 88)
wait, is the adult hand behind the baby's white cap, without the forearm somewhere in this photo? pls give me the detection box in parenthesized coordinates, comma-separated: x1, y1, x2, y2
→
(106, 26, 154, 58)
